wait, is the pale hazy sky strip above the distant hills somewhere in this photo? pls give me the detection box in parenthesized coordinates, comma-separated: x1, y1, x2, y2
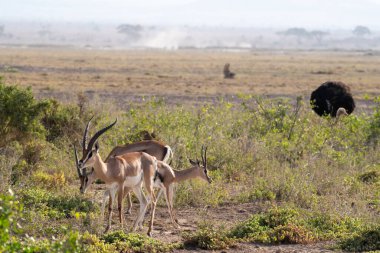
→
(0, 0, 380, 29)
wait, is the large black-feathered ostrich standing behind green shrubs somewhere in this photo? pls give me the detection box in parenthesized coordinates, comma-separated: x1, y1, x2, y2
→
(310, 81, 355, 117)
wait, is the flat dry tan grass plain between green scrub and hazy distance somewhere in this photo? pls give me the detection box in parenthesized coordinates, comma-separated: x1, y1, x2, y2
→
(0, 48, 380, 100)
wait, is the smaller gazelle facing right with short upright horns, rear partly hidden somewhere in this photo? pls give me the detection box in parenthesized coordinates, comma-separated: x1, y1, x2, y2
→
(102, 146, 212, 228)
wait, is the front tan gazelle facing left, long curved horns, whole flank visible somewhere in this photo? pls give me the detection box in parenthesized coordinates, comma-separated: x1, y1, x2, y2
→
(74, 119, 157, 236)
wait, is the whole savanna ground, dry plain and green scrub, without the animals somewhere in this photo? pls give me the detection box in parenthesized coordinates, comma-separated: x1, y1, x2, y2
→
(0, 48, 380, 252)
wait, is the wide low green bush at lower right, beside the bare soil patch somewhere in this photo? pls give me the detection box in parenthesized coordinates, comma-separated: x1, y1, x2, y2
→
(230, 207, 363, 243)
